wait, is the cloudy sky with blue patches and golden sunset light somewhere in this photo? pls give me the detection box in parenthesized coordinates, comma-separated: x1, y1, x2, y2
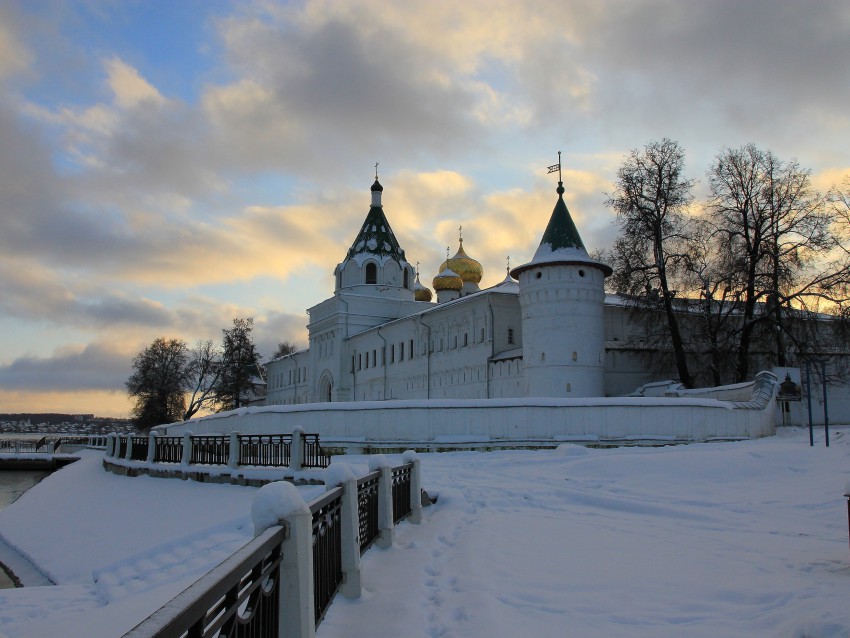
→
(0, 0, 850, 416)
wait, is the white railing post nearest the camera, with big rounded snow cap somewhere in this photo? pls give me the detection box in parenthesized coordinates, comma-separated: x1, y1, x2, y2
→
(251, 481, 316, 638)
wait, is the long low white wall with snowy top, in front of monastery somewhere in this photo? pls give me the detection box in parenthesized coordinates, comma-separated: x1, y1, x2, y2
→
(158, 373, 777, 443)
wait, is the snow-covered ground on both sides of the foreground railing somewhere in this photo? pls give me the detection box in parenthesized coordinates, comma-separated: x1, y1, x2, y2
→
(0, 428, 850, 638)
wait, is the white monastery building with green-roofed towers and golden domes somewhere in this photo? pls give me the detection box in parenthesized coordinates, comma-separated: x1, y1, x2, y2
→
(265, 177, 700, 405)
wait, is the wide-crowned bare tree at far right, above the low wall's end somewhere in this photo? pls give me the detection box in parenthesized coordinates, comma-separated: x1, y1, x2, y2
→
(707, 144, 850, 381)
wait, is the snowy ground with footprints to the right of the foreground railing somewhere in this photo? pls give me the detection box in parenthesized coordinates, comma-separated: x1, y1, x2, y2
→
(318, 429, 850, 638)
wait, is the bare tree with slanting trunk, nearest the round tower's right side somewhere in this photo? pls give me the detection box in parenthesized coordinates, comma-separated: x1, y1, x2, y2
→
(606, 138, 693, 387)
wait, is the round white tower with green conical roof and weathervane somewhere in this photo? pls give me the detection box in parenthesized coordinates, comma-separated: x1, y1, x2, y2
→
(511, 180, 612, 398)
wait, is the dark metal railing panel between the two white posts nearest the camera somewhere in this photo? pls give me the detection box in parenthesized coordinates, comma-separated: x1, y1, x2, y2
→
(310, 487, 342, 625)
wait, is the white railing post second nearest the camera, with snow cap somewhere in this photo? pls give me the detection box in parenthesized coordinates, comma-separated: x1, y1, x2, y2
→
(325, 463, 363, 598)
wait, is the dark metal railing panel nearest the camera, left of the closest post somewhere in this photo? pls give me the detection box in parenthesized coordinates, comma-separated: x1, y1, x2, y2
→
(124, 527, 284, 638)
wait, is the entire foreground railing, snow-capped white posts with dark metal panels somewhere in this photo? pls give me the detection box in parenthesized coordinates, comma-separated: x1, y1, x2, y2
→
(123, 452, 422, 638)
